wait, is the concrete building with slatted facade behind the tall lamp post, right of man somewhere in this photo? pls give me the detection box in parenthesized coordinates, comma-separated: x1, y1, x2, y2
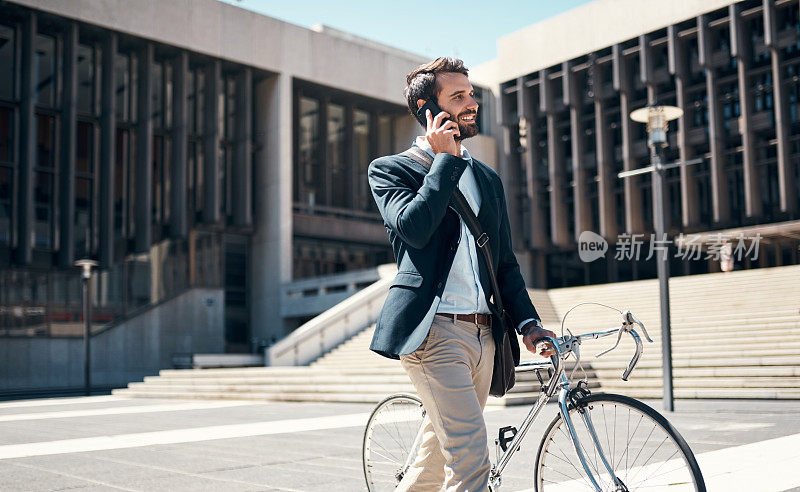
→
(472, 0, 800, 288)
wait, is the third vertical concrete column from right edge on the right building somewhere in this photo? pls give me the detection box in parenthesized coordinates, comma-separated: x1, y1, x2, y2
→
(697, 14, 730, 223)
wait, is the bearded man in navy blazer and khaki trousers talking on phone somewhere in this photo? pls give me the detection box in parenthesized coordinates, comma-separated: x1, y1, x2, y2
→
(368, 58, 555, 492)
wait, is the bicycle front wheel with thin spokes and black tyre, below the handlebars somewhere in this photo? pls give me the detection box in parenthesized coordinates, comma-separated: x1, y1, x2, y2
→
(534, 394, 706, 492)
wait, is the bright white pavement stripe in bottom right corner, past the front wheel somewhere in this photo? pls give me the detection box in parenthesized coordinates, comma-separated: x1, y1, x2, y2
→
(518, 434, 800, 492)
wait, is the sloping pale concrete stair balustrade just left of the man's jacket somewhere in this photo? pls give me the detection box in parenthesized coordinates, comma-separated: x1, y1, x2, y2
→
(265, 264, 397, 366)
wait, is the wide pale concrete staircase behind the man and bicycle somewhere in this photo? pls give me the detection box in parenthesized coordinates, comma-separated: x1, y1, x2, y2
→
(114, 266, 800, 405)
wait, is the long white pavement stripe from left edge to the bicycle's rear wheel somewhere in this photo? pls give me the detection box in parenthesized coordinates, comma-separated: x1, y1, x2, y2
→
(0, 402, 501, 460)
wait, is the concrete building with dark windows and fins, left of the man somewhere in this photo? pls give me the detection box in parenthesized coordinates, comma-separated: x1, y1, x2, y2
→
(0, 0, 494, 393)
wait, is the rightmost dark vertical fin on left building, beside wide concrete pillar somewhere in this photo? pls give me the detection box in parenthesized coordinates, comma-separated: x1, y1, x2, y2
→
(232, 68, 253, 227)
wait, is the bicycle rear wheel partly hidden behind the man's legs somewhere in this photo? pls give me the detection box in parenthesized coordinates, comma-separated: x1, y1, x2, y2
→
(362, 394, 425, 492)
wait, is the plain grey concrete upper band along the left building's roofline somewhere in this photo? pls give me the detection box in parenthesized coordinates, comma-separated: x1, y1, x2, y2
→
(12, 0, 426, 105)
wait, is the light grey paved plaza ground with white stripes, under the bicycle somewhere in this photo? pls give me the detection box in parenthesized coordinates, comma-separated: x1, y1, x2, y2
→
(0, 396, 800, 492)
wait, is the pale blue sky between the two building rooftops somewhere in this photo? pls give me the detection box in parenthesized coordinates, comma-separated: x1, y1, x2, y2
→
(222, 0, 590, 67)
